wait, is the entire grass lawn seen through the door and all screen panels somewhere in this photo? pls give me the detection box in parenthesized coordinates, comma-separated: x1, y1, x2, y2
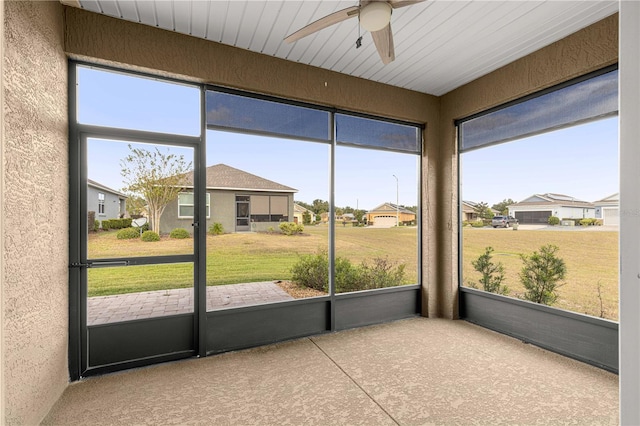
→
(88, 226, 618, 320)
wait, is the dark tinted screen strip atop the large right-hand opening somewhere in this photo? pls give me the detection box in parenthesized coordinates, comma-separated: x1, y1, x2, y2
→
(460, 70, 618, 151)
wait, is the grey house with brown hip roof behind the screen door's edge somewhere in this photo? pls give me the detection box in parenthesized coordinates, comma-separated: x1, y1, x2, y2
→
(160, 164, 298, 233)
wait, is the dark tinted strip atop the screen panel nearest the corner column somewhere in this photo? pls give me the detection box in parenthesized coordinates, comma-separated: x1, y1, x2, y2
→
(335, 114, 420, 153)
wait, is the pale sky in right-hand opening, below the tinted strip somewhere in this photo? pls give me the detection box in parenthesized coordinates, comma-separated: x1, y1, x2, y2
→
(460, 117, 619, 205)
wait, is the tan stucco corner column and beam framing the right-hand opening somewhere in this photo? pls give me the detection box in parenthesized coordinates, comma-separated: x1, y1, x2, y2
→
(432, 14, 618, 318)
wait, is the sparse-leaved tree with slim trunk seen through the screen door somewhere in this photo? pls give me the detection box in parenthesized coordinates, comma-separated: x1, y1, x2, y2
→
(120, 145, 191, 233)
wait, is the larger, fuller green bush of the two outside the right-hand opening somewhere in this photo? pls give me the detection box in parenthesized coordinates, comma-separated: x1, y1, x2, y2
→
(520, 244, 567, 305)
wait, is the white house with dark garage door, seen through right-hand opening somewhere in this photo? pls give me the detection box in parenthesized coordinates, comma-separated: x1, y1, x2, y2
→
(507, 193, 596, 224)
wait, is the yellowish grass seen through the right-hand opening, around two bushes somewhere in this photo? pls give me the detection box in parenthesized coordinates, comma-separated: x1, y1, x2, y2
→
(462, 228, 618, 321)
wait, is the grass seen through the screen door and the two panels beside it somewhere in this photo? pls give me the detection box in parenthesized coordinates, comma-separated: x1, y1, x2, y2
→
(88, 226, 418, 297)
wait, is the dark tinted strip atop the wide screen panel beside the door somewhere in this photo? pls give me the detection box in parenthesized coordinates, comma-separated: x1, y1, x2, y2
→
(206, 91, 331, 141)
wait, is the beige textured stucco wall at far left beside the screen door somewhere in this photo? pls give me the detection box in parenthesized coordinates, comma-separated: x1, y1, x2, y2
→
(0, 1, 69, 425)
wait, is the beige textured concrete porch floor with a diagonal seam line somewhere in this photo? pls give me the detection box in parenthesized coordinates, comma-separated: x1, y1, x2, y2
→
(43, 318, 618, 425)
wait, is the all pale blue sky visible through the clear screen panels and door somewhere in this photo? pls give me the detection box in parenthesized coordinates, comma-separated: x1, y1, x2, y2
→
(78, 68, 618, 210)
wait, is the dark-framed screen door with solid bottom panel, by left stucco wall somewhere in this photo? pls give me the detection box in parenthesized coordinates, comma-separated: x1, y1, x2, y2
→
(71, 135, 199, 376)
